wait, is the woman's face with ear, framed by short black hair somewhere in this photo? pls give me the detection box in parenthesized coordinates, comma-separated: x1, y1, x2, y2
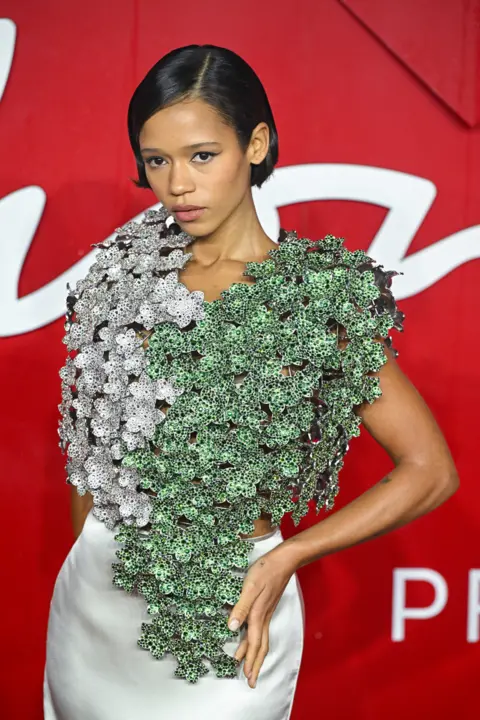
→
(139, 100, 269, 237)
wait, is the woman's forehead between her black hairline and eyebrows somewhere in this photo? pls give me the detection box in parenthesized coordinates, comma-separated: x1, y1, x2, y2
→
(139, 100, 235, 150)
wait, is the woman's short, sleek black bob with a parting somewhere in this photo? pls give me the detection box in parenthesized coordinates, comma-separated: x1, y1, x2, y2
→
(128, 45, 278, 188)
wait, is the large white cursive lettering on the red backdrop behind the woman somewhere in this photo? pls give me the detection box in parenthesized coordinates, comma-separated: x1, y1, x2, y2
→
(0, 19, 480, 337)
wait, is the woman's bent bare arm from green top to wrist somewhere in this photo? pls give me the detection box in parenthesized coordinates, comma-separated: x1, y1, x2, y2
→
(278, 340, 459, 568)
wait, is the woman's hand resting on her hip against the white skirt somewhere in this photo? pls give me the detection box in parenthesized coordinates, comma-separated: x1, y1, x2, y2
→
(228, 543, 296, 688)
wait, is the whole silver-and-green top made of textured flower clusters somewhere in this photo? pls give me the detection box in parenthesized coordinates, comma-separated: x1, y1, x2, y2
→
(59, 209, 404, 682)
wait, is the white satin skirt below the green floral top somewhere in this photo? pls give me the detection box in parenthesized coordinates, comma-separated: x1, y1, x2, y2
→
(44, 512, 305, 720)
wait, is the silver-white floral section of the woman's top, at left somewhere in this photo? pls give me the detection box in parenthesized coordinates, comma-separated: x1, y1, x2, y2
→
(59, 209, 203, 528)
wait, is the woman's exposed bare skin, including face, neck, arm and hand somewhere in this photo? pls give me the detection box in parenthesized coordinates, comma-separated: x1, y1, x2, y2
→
(72, 99, 459, 688)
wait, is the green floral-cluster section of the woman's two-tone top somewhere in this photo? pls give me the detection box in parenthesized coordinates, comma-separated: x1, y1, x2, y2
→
(110, 231, 404, 682)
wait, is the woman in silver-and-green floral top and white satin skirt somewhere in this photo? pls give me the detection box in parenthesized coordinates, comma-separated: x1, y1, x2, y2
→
(45, 45, 458, 720)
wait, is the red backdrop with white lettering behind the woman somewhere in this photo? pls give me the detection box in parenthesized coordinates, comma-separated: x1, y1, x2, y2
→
(0, 0, 480, 720)
